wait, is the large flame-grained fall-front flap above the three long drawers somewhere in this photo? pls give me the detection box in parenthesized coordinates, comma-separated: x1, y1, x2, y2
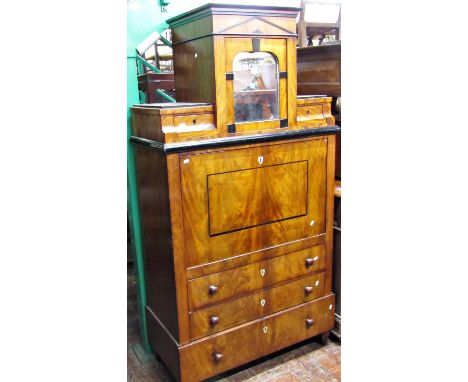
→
(179, 138, 327, 267)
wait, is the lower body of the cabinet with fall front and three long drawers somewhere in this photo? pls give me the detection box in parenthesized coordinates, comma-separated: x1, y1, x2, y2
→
(134, 132, 335, 381)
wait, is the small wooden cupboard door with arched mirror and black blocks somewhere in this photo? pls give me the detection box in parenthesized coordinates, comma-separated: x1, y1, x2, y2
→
(224, 38, 288, 132)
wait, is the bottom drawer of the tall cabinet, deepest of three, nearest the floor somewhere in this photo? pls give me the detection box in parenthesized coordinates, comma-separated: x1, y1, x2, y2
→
(180, 294, 335, 381)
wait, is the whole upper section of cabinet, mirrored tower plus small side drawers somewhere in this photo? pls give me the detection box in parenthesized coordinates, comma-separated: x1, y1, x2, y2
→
(132, 4, 334, 146)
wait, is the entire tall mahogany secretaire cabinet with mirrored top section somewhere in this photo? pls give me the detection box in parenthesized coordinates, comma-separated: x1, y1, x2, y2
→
(131, 5, 339, 382)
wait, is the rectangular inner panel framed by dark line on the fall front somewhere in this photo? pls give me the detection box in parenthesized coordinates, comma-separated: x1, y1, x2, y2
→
(208, 157, 307, 236)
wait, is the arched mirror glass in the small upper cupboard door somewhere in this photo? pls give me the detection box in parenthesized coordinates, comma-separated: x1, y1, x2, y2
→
(232, 52, 279, 123)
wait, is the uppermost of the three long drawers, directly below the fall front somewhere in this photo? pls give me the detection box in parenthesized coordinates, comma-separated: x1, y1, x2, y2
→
(188, 244, 326, 310)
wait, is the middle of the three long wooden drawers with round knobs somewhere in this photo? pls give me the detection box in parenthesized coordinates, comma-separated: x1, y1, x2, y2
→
(190, 272, 325, 339)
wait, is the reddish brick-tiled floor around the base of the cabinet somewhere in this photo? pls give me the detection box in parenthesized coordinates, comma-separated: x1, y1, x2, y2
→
(127, 269, 341, 382)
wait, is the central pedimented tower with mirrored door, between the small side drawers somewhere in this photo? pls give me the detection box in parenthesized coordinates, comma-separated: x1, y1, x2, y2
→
(168, 4, 300, 136)
